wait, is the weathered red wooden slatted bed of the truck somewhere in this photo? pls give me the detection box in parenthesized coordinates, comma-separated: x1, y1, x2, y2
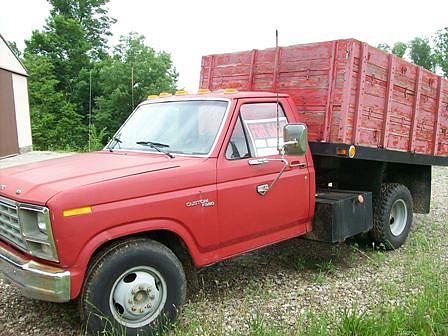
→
(200, 39, 448, 161)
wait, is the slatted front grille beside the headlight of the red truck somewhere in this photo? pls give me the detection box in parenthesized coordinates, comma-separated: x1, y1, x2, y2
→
(0, 197, 26, 249)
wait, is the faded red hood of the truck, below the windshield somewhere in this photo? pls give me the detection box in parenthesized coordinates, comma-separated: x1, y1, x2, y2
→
(0, 151, 196, 205)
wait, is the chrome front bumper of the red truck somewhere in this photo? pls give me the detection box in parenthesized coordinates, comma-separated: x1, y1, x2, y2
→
(0, 246, 70, 302)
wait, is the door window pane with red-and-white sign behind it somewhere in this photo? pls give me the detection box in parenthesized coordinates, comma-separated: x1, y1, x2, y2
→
(240, 103, 288, 157)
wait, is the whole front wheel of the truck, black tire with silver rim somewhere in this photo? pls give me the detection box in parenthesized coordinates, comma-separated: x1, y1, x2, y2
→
(81, 239, 186, 335)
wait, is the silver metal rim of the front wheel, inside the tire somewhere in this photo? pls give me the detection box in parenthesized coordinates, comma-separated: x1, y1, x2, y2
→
(109, 266, 167, 328)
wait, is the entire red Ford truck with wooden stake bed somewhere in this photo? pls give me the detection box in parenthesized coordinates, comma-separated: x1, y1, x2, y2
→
(0, 40, 448, 335)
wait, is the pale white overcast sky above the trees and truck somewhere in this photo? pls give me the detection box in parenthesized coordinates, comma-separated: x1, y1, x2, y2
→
(0, 0, 448, 91)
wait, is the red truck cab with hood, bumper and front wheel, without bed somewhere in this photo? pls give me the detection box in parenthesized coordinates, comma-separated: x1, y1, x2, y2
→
(0, 90, 315, 334)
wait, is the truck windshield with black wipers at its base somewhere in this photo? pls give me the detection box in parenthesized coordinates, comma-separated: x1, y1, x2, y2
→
(112, 100, 228, 155)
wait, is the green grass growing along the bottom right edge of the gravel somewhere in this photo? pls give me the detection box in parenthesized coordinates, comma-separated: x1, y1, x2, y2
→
(171, 260, 448, 336)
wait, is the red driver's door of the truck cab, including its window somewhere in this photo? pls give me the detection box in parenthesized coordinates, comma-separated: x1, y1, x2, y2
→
(217, 99, 310, 255)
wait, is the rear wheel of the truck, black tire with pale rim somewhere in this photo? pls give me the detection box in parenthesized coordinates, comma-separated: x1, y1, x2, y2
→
(371, 183, 413, 250)
